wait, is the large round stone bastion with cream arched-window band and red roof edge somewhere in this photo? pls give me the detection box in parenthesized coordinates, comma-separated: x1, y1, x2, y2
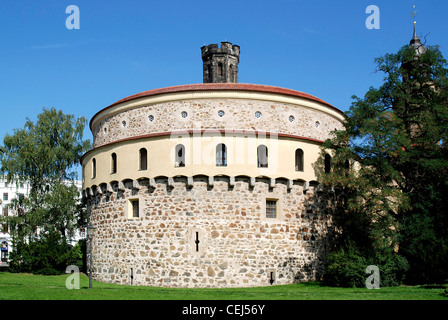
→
(81, 83, 344, 288)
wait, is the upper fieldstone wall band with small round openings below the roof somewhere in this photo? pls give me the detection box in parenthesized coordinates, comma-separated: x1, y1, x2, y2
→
(93, 99, 341, 148)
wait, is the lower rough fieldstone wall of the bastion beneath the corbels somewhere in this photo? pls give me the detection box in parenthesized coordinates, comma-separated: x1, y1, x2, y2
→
(86, 176, 331, 288)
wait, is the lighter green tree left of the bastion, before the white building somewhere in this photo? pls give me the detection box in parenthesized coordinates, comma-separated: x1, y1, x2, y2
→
(1, 108, 90, 268)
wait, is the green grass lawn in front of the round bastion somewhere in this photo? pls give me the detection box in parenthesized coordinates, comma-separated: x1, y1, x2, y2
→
(0, 272, 448, 300)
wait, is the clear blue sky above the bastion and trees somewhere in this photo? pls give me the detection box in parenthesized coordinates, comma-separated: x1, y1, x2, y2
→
(0, 0, 448, 160)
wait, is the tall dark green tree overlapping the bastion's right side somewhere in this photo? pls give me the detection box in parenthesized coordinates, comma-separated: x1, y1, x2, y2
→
(316, 42, 448, 283)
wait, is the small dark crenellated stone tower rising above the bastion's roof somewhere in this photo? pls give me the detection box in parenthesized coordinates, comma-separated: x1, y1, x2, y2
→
(201, 41, 240, 83)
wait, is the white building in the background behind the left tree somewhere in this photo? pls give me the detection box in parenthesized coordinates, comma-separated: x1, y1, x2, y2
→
(0, 176, 86, 267)
